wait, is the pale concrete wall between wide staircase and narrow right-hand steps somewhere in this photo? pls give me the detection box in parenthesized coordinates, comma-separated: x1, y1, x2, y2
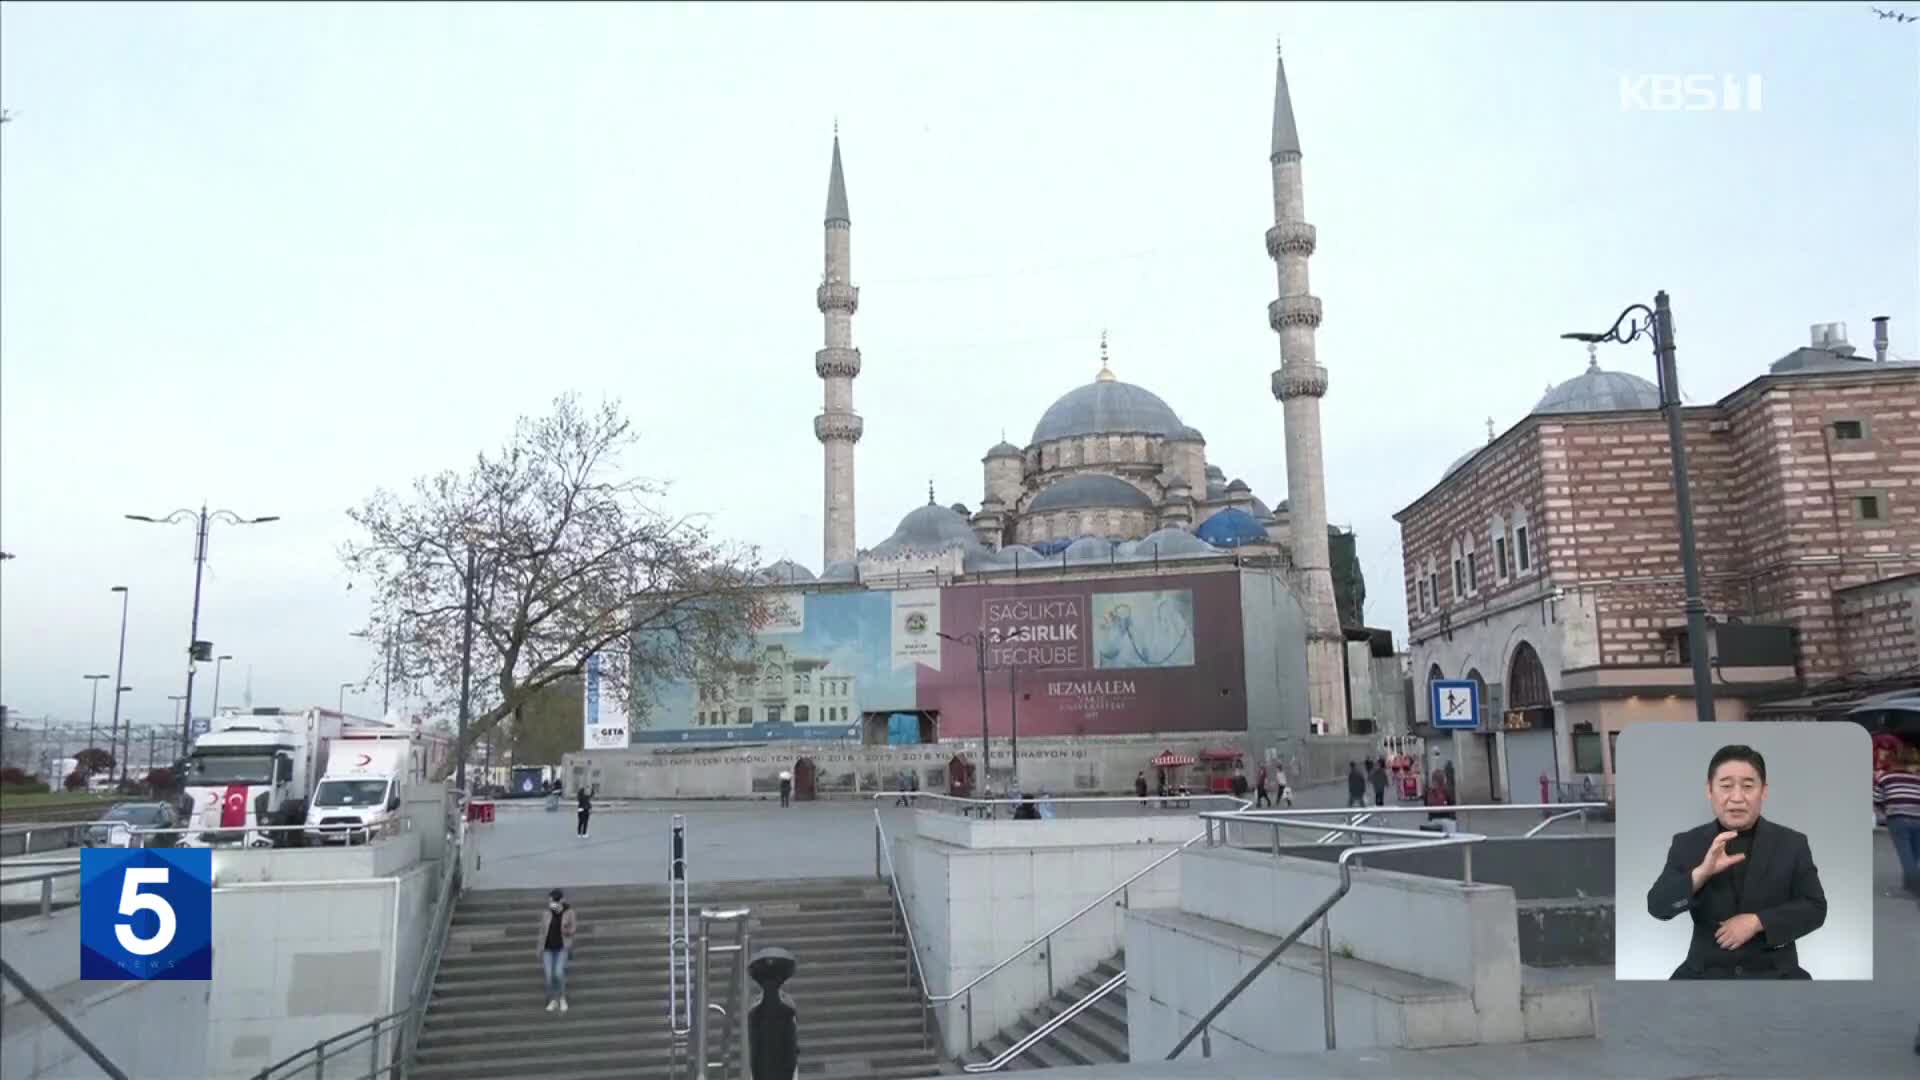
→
(893, 811, 1204, 1055)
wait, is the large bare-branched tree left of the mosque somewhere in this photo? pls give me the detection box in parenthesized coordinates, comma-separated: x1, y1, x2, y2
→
(342, 396, 760, 769)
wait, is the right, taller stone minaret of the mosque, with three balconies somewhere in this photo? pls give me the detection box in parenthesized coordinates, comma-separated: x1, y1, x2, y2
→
(1267, 46, 1346, 732)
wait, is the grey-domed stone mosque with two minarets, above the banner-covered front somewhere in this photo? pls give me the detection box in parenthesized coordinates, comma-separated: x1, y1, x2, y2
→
(794, 48, 1363, 724)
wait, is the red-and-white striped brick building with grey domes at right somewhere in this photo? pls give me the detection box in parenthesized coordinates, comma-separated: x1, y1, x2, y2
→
(1394, 321, 1920, 801)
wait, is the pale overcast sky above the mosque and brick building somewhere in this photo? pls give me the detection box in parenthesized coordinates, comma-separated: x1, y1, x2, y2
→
(0, 4, 1920, 724)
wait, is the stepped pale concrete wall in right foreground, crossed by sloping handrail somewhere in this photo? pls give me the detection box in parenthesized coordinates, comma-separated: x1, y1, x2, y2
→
(1127, 847, 1526, 1061)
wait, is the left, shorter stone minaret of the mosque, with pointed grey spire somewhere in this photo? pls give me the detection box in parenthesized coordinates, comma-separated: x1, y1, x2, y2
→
(814, 123, 864, 569)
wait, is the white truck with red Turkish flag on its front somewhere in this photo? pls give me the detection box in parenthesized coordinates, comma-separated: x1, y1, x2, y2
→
(180, 709, 378, 847)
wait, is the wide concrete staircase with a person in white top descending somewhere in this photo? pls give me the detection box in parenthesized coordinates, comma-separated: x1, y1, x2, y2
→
(411, 878, 941, 1080)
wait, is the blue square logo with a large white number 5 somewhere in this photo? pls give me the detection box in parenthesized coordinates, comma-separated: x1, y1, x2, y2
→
(81, 847, 213, 982)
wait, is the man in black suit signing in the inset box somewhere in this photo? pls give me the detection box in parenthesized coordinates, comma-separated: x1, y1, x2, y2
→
(1647, 746, 1826, 978)
